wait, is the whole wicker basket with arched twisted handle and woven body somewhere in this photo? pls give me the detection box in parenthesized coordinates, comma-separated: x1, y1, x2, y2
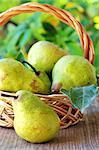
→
(0, 3, 94, 128)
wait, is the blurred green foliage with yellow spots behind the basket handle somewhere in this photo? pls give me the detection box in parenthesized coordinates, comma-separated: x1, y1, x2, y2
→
(0, 0, 99, 74)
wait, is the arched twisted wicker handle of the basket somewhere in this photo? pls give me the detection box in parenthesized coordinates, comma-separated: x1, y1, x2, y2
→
(0, 3, 95, 64)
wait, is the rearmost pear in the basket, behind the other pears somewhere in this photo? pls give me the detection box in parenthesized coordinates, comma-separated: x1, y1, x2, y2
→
(28, 41, 67, 73)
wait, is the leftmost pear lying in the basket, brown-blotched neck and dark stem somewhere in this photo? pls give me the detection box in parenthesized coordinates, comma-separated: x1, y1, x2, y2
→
(0, 58, 51, 94)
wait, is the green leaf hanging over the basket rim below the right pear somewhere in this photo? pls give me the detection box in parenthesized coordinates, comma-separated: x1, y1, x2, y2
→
(61, 85, 99, 112)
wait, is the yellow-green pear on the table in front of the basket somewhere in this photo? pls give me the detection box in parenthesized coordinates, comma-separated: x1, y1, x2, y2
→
(12, 90, 60, 143)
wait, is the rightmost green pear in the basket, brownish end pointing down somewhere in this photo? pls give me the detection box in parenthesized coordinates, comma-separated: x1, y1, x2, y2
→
(52, 55, 96, 93)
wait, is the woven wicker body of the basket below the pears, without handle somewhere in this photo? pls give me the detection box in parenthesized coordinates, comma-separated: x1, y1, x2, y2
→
(0, 91, 83, 128)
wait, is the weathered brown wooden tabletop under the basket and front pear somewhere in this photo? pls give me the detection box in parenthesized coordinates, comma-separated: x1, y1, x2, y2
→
(0, 99, 99, 150)
